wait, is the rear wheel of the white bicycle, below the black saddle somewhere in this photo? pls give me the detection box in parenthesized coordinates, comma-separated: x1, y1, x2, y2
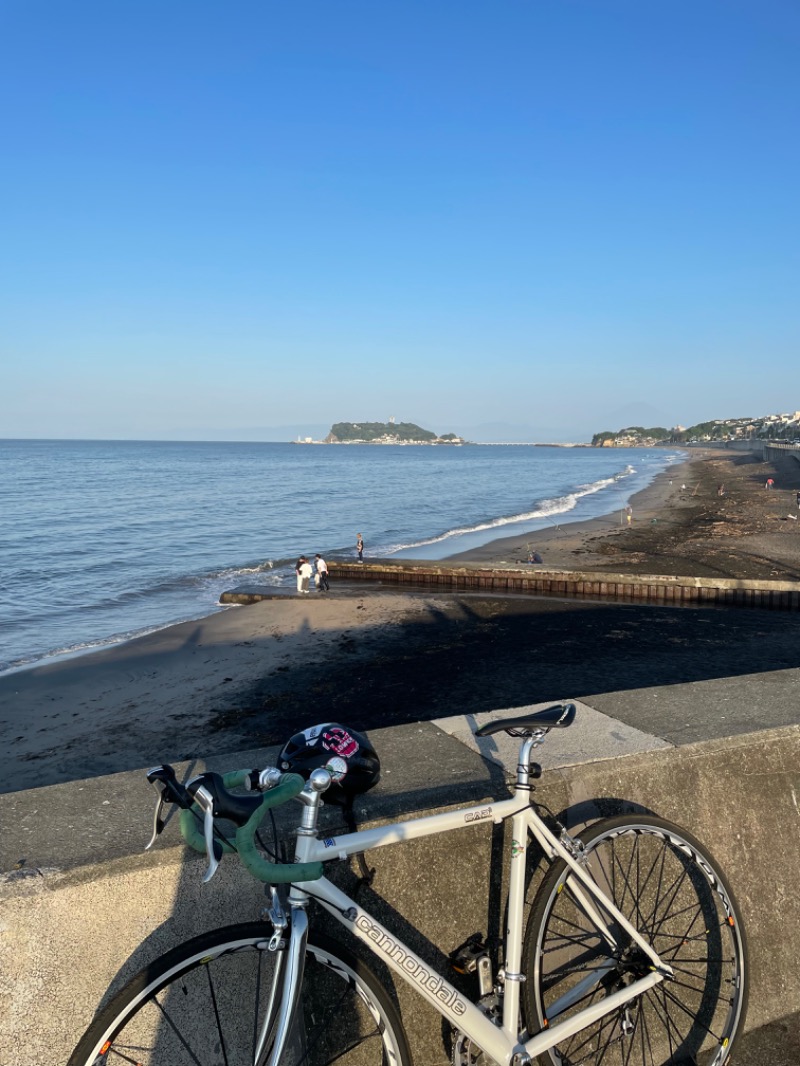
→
(524, 815, 748, 1066)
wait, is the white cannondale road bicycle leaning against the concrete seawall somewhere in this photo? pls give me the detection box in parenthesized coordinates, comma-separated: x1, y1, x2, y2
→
(69, 704, 748, 1066)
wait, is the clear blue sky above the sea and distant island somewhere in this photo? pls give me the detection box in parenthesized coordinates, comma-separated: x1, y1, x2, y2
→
(0, 0, 800, 440)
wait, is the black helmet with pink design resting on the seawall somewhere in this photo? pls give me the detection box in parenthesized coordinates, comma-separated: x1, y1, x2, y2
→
(277, 722, 381, 803)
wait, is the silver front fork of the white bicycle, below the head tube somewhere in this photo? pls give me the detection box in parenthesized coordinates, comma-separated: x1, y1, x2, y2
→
(254, 906, 308, 1066)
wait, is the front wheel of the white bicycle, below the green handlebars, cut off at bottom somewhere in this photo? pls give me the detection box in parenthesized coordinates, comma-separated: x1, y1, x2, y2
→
(68, 922, 411, 1066)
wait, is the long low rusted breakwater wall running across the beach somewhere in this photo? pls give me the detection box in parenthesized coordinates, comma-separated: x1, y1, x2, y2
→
(327, 561, 800, 611)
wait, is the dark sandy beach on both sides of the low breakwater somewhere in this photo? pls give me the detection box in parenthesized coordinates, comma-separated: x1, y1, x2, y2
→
(0, 450, 800, 792)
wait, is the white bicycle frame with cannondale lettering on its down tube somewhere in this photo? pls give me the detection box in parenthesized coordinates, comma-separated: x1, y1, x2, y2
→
(272, 780, 672, 1066)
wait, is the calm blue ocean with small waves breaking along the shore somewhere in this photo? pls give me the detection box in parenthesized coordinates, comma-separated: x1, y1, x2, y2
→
(0, 440, 682, 672)
